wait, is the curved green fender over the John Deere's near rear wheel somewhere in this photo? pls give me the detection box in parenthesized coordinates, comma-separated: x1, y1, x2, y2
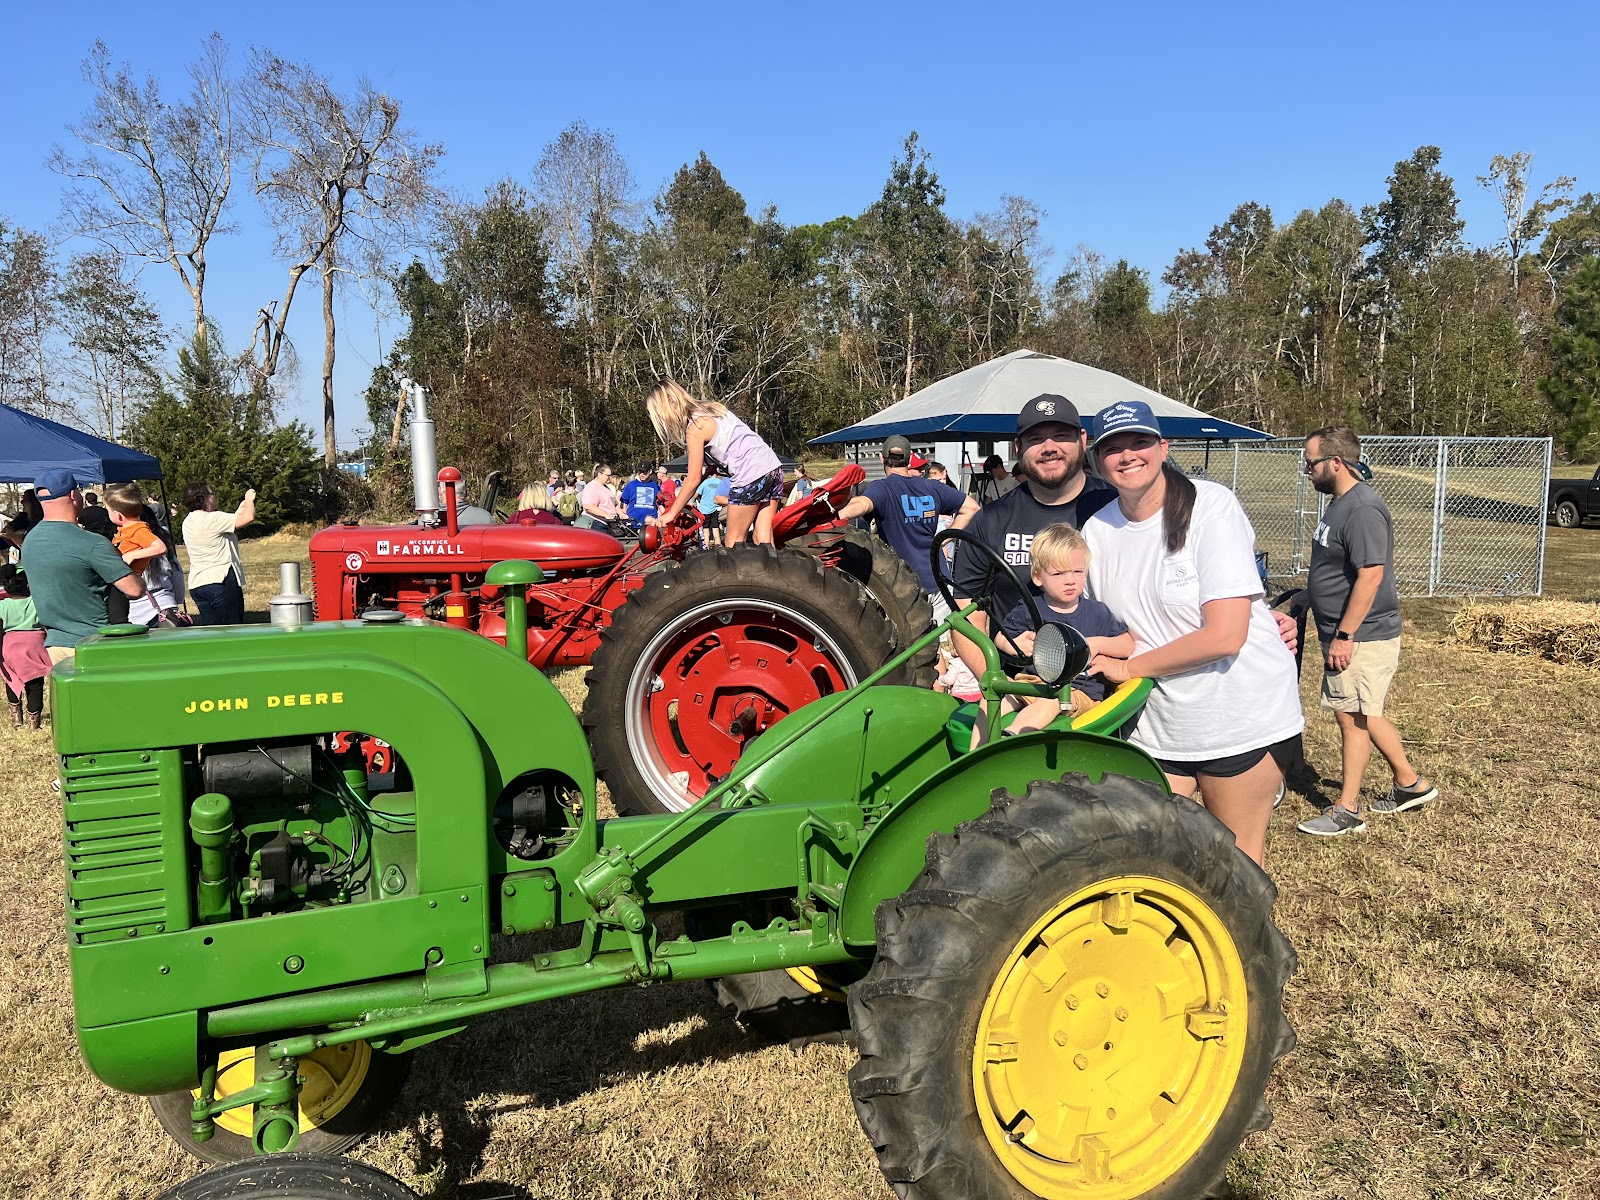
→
(840, 730, 1166, 946)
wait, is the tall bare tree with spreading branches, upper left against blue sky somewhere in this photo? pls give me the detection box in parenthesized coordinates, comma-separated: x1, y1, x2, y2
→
(48, 34, 237, 338)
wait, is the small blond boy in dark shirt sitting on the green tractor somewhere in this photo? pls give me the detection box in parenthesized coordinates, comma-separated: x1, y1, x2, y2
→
(1000, 525, 1134, 733)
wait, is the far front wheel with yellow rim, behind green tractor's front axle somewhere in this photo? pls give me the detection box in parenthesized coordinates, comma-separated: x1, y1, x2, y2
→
(150, 1042, 411, 1163)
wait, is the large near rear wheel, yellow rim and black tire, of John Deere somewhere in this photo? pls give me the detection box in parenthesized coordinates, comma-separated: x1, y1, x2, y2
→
(850, 774, 1294, 1200)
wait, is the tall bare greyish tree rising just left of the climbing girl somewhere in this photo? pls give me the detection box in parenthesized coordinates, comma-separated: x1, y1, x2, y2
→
(533, 120, 638, 395)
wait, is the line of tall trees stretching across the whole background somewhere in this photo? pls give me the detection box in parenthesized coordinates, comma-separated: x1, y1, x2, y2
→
(0, 35, 1600, 515)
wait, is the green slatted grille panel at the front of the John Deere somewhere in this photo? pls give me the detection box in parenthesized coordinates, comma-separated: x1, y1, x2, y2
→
(61, 750, 192, 946)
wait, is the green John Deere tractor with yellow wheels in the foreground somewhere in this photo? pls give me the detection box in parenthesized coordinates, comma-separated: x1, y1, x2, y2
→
(54, 534, 1294, 1200)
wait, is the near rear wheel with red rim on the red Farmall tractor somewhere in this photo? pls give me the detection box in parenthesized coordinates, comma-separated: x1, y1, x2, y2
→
(582, 546, 915, 813)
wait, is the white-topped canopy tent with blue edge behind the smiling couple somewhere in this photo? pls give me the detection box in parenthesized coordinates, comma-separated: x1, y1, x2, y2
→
(811, 350, 1272, 445)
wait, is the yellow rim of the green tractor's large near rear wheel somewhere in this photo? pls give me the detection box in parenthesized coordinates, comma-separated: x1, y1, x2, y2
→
(973, 875, 1250, 1200)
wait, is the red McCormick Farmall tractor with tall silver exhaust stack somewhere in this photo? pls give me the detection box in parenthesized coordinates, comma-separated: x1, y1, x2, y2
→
(310, 386, 934, 813)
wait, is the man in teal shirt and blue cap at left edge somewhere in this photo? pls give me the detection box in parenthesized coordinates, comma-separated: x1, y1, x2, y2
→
(22, 467, 144, 662)
